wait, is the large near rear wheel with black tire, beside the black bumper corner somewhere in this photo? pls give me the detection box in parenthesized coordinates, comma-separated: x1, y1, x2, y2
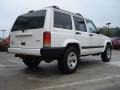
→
(58, 47, 79, 74)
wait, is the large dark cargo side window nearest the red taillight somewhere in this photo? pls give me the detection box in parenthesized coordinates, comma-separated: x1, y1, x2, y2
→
(54, 11, 72, 29)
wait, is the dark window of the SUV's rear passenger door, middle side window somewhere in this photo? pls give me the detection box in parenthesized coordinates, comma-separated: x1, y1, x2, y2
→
(73, 17, 87, 32)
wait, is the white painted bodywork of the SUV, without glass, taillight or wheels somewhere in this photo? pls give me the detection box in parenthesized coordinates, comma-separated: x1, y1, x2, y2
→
(9, 7, 110, 56)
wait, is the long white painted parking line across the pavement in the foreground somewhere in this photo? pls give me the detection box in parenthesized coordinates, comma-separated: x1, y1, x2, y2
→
(32, 75, 120, 90)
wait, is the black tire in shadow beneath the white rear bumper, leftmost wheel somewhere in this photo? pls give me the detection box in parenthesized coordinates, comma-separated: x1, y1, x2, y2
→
(23, 58, 41, 68)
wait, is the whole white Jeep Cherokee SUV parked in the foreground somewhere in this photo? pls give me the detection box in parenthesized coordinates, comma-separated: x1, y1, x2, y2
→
(8, 6, 112, 74)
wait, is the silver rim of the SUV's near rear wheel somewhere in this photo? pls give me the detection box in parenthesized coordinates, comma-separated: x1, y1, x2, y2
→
(67, 52, 77, 69)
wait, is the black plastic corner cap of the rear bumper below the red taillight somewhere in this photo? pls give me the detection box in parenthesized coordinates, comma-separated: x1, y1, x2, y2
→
(40, 47, 65, 58)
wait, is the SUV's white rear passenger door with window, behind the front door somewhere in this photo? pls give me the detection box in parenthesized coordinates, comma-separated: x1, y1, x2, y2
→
(73, 17, 90, 54)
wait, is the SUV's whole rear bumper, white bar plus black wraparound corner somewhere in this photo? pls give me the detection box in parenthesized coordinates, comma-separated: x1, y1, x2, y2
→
(8, 47, 65, 58)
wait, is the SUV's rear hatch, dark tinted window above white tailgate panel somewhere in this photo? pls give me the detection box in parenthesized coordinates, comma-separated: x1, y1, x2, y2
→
(10, 10, 46, 49)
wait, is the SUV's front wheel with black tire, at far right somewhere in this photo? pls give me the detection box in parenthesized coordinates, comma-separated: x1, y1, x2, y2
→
(101, 45, 112, 62)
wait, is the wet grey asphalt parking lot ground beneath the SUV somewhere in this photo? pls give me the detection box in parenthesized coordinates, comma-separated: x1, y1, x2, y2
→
(0, 50, 120, 90)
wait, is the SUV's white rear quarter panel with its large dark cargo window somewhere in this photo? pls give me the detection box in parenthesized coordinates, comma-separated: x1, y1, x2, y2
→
(51, 10, 75, 47)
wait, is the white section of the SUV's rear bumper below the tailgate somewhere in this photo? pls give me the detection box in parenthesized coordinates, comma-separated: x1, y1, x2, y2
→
(8, 48, 41, 56)
